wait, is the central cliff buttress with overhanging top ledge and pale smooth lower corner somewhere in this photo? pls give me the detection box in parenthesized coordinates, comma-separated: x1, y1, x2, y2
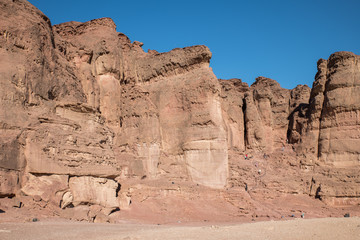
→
(54, 18, 227, 187)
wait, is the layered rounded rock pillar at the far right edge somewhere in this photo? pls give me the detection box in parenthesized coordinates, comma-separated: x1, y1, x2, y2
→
(289, 52, 360, 205)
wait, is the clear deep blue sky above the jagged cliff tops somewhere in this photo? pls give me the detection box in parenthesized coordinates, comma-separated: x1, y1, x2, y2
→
(26, 0, 360, 88)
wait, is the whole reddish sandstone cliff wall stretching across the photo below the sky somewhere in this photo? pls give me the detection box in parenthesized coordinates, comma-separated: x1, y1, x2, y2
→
(0, 0, 360, 221)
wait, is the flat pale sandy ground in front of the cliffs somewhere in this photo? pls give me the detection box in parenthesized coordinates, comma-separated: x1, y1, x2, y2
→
(0, 217, 360, 240)
